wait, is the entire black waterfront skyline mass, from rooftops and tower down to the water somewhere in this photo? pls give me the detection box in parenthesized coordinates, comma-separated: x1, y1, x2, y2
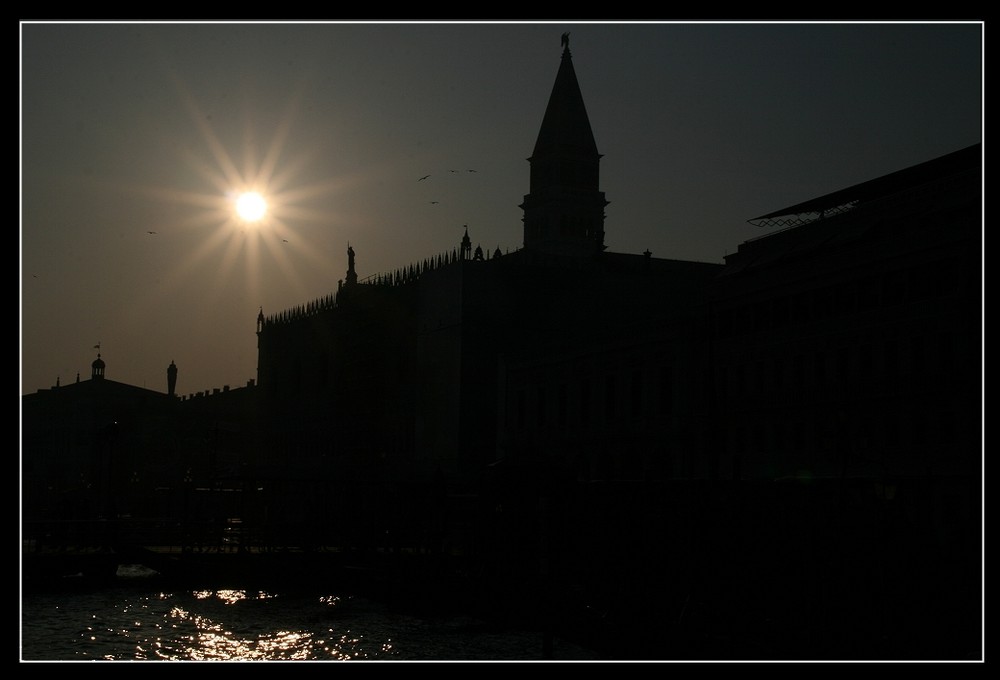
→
(22, 35, 983, 660)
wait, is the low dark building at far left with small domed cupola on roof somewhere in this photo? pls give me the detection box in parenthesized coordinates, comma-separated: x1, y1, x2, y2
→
(21, 354, 259, 526)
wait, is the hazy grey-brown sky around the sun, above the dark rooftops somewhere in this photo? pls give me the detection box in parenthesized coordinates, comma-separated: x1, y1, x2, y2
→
(20, 23, 983, 394)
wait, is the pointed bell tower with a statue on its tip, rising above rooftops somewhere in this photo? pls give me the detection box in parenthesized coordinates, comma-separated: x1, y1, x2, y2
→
(519, 33, 608, 256)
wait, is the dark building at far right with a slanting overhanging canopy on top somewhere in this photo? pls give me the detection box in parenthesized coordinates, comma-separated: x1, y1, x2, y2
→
(711, 145, 982, 486)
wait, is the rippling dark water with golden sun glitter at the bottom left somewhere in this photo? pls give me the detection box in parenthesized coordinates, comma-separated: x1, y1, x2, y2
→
(21, 589, 593, 662)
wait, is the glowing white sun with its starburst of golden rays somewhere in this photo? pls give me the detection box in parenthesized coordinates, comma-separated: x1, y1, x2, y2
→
(133, 77, 350, 313)
